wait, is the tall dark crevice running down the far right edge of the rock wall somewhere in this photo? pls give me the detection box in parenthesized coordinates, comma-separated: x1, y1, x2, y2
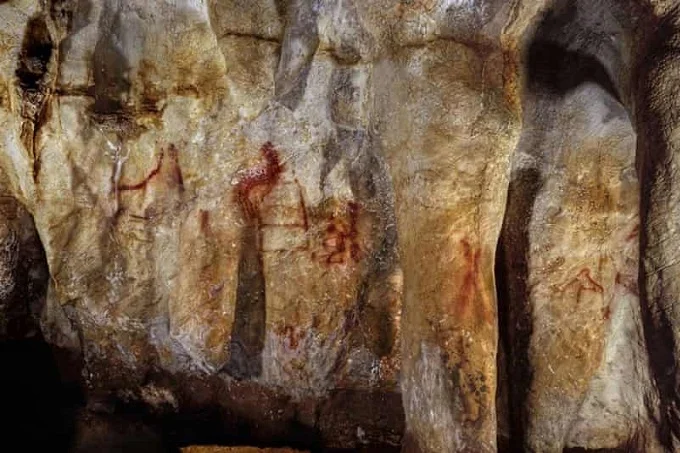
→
(635, 6, 680, 451)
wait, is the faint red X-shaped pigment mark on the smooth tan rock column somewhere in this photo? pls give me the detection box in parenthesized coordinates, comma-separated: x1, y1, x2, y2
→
(456, 239, 493, 323)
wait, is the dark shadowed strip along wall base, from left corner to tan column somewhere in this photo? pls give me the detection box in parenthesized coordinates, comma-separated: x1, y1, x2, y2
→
(0, 370, 403, 453)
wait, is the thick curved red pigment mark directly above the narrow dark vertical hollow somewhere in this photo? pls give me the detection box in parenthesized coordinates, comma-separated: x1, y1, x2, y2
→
(235, 142, 283, 221)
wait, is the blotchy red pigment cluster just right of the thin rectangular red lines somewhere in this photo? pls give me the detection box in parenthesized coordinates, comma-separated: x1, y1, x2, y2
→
(322, 201, 361, 264)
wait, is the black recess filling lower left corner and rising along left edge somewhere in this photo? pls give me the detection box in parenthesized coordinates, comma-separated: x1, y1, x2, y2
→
(0, 199, 83, 452)
